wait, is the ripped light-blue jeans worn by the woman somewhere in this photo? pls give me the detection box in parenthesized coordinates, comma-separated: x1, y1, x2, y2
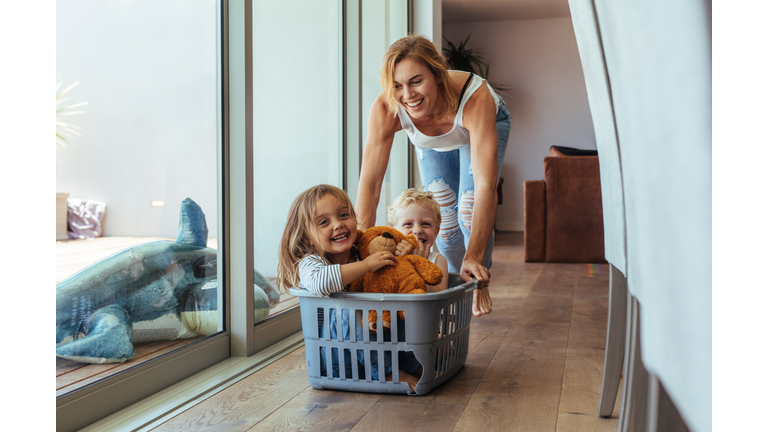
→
(416, 101, 511, 273)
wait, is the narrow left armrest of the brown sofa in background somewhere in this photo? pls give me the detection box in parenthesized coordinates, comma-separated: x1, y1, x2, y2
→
(523, 180, 547, 262)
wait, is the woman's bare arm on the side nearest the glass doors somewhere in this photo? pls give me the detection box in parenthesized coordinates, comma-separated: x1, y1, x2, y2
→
(355, 93, 402, 230)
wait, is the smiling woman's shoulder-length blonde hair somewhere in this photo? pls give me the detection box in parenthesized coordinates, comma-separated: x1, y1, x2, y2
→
(380, 35, 459, 115)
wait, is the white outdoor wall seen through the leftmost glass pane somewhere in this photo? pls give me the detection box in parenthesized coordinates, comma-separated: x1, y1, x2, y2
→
(56, 0, 218, 237)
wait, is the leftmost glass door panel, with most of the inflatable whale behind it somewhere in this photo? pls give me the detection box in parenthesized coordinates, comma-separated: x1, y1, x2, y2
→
(56, 0, 229, 430)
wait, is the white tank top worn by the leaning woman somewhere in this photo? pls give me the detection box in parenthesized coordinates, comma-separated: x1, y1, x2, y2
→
(397, 71, 500, 151)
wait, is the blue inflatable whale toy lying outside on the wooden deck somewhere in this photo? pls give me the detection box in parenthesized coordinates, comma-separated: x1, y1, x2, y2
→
(56, 198, 280, 363)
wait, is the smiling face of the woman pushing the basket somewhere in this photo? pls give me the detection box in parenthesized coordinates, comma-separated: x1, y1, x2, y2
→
(394, 58, 442, 118)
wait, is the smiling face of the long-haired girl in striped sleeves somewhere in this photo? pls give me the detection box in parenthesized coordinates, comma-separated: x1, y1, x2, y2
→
(315, 194, 357, 264)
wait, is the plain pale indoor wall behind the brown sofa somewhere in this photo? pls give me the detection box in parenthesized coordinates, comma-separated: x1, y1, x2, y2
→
(443, 18, 595, 231)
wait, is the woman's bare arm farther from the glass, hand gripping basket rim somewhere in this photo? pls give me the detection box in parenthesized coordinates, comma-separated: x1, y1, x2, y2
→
(461, 84, 499, 288)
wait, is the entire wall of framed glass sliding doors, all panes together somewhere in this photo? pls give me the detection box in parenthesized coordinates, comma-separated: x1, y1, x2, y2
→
(57, 0, 420, 431)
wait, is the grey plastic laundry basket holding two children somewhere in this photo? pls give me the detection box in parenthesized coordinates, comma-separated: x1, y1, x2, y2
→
(290, 274, 477, 396)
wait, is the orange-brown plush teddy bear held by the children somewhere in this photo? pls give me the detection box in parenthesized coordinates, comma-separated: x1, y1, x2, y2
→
(349, 226, 443, 328)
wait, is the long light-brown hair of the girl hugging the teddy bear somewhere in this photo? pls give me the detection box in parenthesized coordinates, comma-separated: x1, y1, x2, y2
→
(277, 184, 357, 292)
